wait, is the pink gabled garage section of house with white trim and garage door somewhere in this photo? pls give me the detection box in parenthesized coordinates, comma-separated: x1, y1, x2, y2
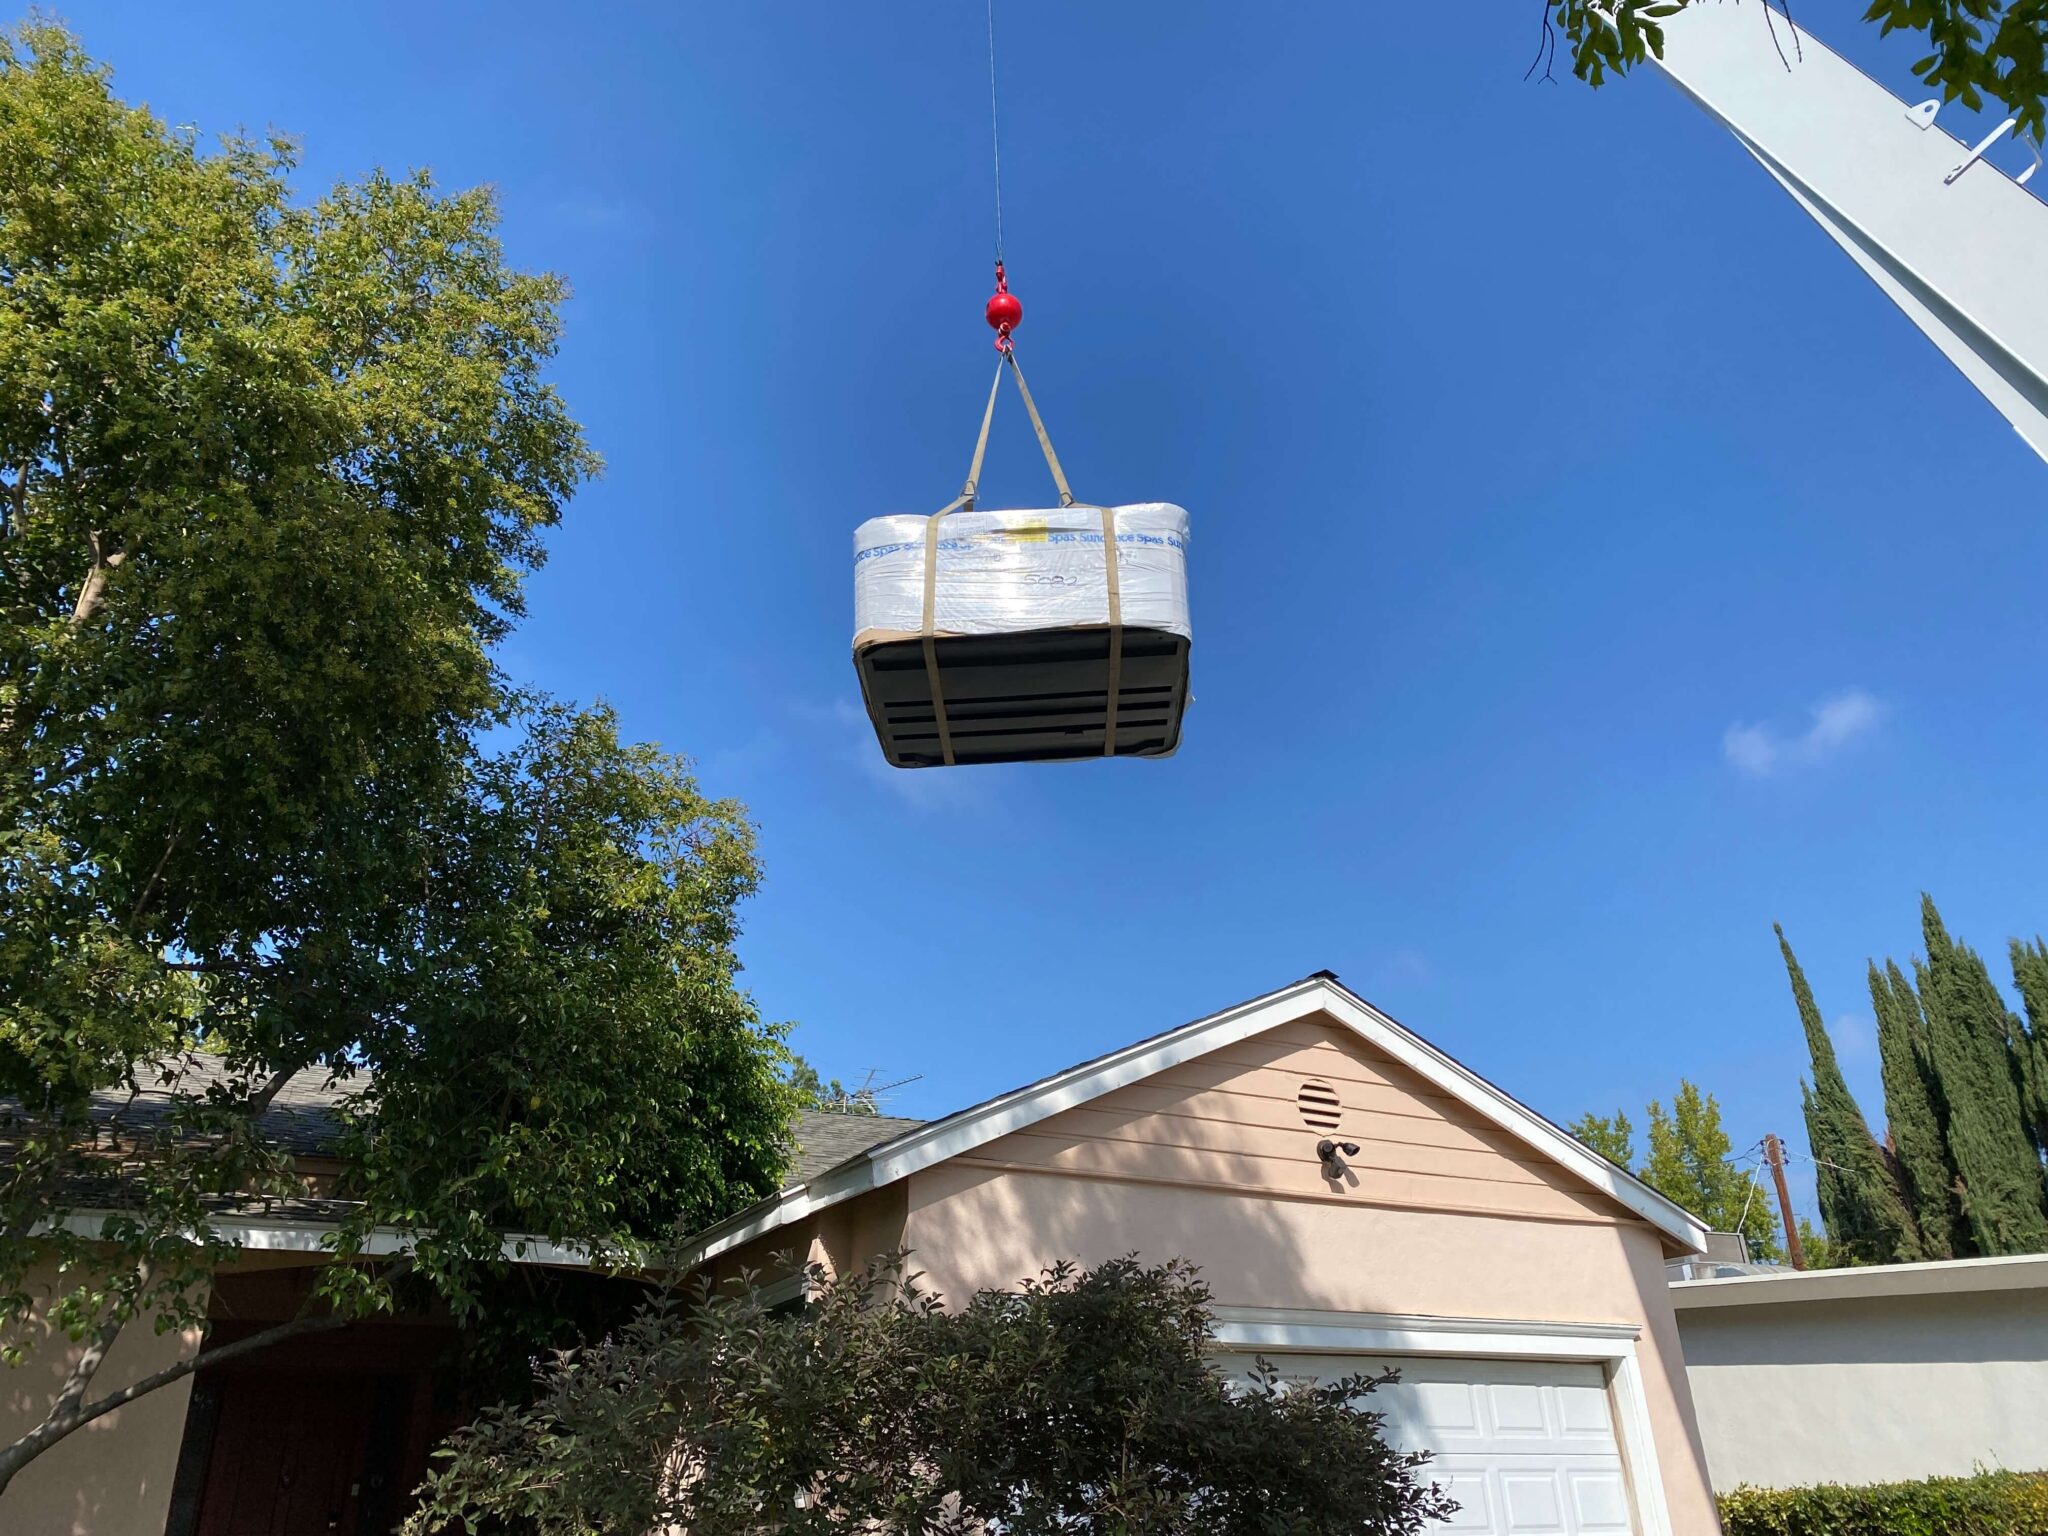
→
(692, 973, 1718, 1536)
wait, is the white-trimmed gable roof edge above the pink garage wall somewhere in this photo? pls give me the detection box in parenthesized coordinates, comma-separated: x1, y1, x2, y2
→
(684, 971, 1708, 1264)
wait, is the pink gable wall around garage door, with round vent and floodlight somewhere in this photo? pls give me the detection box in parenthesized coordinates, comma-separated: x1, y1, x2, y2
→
(712, 1014, 1718, 1536)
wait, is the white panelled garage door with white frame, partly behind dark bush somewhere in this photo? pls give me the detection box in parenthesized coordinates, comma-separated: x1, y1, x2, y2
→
(1228, 1354, 1634, 1536)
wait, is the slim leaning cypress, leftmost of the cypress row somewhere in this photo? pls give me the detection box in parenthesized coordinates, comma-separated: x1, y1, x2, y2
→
(1774, 926, 1921, 1264)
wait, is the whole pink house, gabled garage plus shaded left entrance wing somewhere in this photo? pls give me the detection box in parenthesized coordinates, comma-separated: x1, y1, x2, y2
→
(0, 973, 1716, 1536)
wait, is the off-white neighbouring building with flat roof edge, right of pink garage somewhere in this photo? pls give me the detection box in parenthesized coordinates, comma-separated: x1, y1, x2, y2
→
(1677, 1290, 2048, 1489)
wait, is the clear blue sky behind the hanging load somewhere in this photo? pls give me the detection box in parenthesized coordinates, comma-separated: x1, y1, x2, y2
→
(66, 0, 2048, 1220)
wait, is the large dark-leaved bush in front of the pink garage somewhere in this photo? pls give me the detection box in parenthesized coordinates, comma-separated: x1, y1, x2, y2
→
(406, 1260, 1454, 1536)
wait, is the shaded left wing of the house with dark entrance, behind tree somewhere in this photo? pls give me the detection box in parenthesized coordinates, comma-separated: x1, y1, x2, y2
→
(0, 1055, 621, 1536)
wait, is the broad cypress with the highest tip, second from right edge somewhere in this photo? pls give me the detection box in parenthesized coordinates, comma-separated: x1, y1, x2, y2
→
(1919, 895, 2048, 1255)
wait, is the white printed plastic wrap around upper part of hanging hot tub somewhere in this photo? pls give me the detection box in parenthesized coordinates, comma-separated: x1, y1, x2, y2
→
(854, 502, 1194, 649)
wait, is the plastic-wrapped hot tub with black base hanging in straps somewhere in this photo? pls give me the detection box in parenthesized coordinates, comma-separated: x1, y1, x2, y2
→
(854, 502, 1192, 768)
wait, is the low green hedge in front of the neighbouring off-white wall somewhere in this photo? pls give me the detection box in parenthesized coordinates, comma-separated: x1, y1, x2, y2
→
(1720, 1473, 2048, 1536)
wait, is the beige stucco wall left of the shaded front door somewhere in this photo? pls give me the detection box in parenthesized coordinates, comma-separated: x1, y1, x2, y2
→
(0, 1272, 199, 1536)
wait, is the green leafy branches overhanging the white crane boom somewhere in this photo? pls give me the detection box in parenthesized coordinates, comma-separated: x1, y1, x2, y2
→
(1544, 0, 2048, 141)
